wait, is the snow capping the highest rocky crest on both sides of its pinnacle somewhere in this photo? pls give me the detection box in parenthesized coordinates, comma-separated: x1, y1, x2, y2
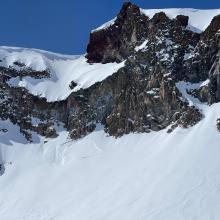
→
(92, 8, 220, 33)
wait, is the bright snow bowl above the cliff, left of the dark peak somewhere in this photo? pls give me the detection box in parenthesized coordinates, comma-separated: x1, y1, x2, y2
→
(0, 47, 124, 102)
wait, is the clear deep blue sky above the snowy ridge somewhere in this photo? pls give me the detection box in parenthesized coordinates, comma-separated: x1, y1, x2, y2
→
(0, 0, 220, 54)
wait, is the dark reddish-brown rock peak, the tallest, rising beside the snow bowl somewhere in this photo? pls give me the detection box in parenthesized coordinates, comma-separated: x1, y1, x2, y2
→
(87, 3, 148, 63)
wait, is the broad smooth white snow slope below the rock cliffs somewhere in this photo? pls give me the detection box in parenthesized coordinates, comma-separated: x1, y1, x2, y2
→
(0, 82, 220, 220)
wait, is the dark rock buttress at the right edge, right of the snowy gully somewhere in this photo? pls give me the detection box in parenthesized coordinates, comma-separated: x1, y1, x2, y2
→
(184, 15, 220, 104)
